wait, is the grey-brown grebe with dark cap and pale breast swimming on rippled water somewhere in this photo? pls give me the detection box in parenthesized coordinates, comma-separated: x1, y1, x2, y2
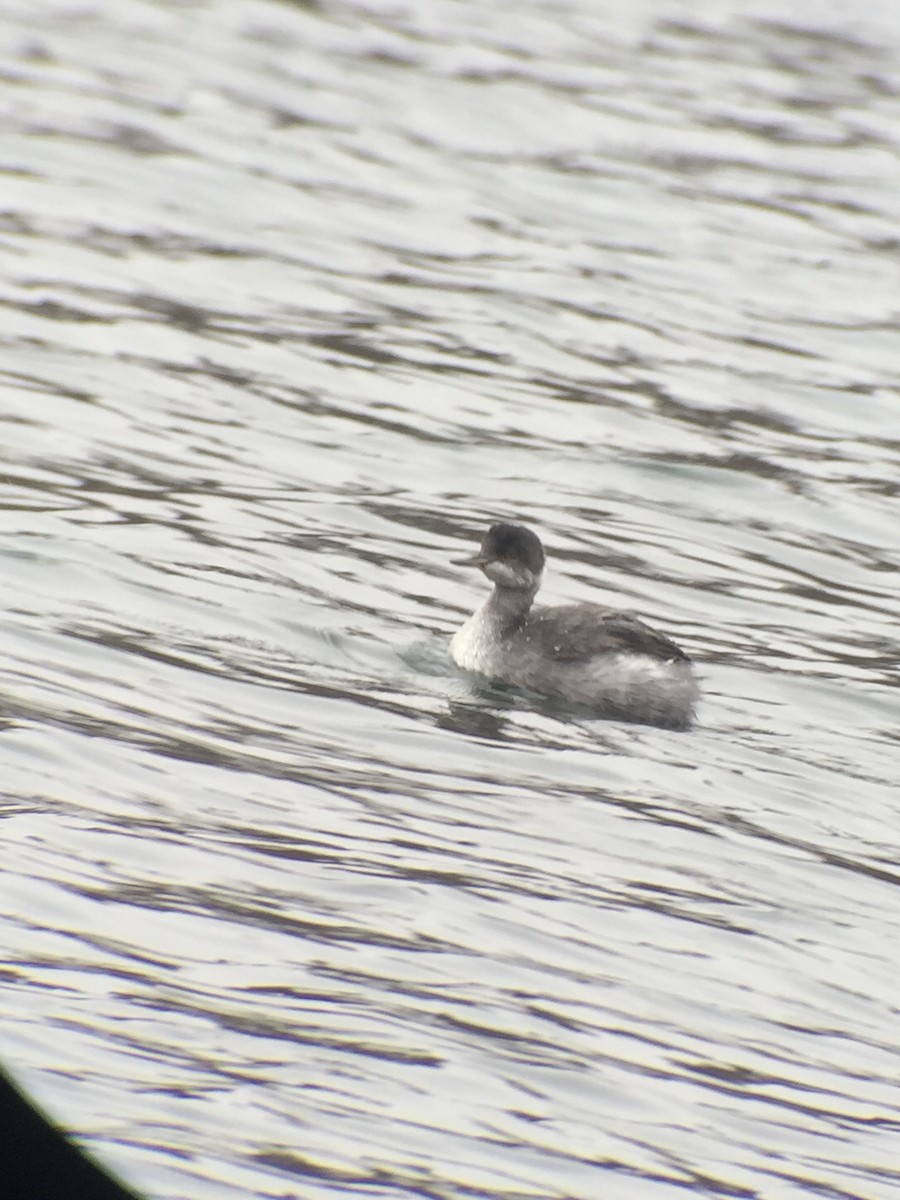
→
(450, 523, 700, 730)
